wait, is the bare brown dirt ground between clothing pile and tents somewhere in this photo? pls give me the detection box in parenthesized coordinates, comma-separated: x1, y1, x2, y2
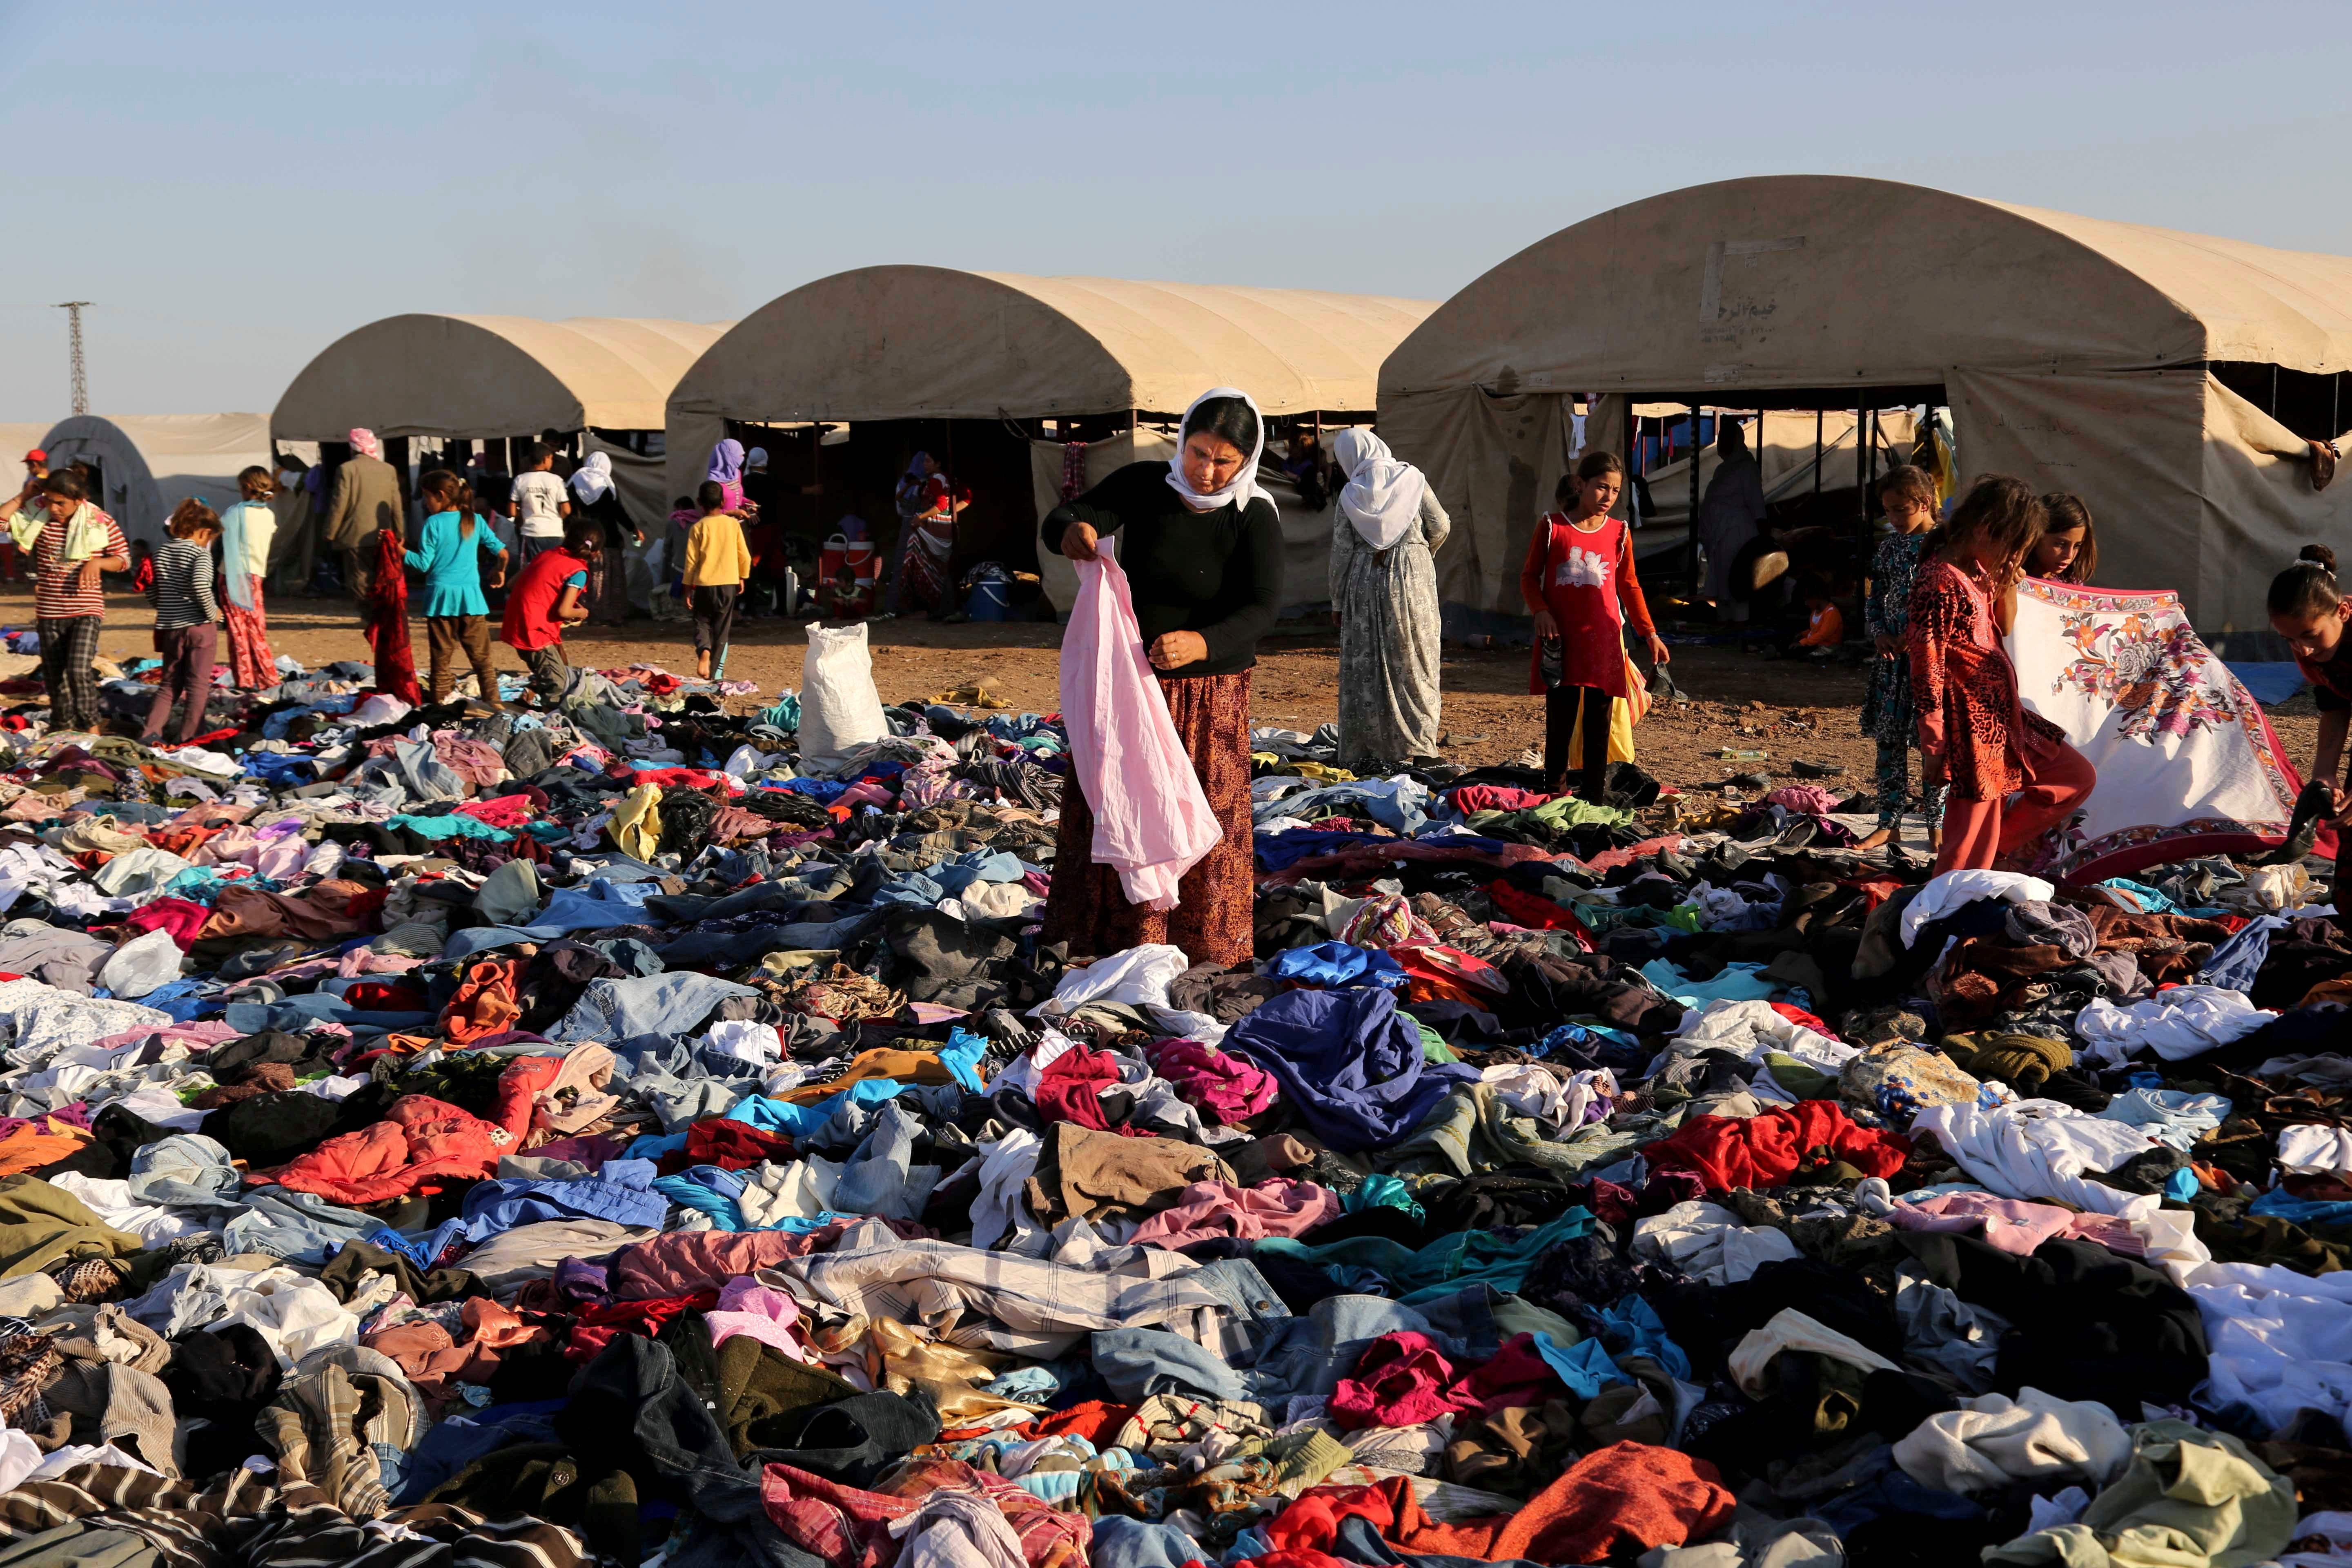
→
(27, 586, 2317, 790)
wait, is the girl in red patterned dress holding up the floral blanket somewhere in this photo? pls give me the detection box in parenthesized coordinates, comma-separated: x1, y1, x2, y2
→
(1907, 475, 2098, 875)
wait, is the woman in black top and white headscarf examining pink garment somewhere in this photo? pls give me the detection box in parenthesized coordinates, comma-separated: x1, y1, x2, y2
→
(1042, 388, 1282, 966)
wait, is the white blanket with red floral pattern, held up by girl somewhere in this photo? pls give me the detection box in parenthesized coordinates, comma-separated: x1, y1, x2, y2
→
(2009, 578, 2303, 882)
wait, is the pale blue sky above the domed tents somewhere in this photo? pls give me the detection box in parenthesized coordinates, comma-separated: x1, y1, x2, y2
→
(0, 0, 2352, 421)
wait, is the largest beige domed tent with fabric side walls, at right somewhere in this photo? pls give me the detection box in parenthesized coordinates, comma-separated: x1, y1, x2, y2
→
(1378, 176, 2352, 633)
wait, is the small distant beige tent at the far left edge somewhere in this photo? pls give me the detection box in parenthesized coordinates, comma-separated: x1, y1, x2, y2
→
(34, 414, 318, 546)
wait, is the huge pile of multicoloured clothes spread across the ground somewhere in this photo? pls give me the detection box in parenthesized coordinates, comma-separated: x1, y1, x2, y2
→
(0, 668, 2352, 1568)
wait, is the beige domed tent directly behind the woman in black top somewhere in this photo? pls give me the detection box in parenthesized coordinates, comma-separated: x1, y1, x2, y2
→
(668, 266, 1435, 604)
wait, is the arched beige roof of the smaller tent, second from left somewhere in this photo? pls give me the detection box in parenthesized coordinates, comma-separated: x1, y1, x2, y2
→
(270, 315, 731, 442)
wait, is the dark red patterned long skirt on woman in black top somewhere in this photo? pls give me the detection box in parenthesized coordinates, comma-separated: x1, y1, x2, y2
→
(1044, 670, 1254, 964)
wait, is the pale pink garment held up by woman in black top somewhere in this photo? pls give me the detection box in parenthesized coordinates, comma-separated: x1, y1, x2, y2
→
(1061, 538, 1225, 910)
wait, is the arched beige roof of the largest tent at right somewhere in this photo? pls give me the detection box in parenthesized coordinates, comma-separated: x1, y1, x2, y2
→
(1381, 174, 2352, 402)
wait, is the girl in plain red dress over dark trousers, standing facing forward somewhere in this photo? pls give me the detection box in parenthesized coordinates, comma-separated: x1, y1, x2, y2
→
(1519, 451, 1670, 802)
